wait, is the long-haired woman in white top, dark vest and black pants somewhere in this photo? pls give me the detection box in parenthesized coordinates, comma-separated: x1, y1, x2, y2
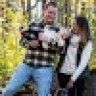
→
(58, 16, 92, 96)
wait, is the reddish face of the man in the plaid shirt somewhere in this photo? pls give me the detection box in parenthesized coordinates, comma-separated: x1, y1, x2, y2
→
(44, 6, 57, 24)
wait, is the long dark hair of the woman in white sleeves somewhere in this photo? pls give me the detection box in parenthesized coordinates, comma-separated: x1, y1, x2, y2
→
(76, 16, 91, 41)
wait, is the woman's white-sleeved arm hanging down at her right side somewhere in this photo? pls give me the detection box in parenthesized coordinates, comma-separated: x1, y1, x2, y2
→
(71, 41, 92, 82)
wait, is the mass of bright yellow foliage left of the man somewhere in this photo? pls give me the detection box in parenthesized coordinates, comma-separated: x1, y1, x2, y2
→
(0, 5, 27, 78)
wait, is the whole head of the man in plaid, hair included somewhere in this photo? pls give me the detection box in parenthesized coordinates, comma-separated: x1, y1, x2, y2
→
(43, 2, 57, 24)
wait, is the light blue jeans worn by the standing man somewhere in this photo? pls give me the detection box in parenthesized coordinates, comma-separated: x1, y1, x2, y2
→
(2, 64, 53, 96)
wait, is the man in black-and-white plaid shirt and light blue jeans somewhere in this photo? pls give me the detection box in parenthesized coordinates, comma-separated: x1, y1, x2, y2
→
(3, 2, 63, 96)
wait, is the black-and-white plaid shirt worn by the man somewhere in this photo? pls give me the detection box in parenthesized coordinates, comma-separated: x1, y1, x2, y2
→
(20, 23, 59, 66)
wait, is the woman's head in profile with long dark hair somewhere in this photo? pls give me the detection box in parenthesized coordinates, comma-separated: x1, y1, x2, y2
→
(74, 16, 90, 40)
